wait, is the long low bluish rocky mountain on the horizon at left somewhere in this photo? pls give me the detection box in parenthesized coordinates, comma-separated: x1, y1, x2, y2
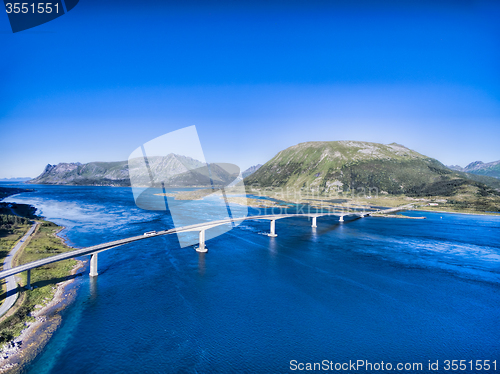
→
(27, 154, 239, 187)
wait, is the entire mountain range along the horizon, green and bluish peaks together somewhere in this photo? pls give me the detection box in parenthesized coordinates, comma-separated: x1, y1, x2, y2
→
(24, 141, 500, 211)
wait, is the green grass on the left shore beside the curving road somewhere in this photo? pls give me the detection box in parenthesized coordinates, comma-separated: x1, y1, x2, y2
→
(0, 220, 77, 344)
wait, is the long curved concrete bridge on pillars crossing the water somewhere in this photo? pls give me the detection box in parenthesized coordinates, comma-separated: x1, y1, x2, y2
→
(0, 204, 411, 289)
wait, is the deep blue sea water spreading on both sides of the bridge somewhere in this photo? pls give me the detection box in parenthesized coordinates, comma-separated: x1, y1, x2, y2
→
(0, 186, 500, 374)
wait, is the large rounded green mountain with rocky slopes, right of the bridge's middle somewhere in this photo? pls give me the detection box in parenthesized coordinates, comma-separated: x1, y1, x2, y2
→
(245, 141, 500, 200)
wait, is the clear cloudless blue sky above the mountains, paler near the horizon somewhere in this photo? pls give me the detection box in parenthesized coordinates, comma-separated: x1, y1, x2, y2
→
(0, 0, 500, 177)
